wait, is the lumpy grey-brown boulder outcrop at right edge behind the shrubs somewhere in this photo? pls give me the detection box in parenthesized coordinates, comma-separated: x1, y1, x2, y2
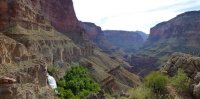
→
(161, 53, 200, 99)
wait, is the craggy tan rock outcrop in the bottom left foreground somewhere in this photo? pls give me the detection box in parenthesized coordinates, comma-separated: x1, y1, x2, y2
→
(0, 60, 56, 99)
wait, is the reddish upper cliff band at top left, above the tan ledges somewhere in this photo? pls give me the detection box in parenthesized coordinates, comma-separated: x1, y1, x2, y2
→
(0, 0, 78, 32)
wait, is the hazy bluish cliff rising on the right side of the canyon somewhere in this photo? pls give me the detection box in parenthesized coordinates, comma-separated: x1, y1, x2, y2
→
(140, 11, 200, 57)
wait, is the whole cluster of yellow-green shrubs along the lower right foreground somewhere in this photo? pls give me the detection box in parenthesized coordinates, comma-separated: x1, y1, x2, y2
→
(129, 69, 190, 99)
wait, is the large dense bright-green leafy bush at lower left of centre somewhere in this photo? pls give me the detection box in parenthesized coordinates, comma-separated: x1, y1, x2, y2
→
(58, 65, 100, 99)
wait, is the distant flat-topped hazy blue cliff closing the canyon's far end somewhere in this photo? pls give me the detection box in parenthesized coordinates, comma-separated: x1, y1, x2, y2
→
(103, 30, 145, 52)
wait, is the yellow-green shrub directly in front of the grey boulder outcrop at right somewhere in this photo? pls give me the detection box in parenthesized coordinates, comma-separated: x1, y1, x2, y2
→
(171, 69, 190, 92)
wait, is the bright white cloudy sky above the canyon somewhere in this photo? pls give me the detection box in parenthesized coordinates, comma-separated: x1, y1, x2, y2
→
(73, 0, 200, 34)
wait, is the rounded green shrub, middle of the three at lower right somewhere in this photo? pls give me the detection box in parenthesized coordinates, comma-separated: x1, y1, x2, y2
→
(144, 72, 168, 94)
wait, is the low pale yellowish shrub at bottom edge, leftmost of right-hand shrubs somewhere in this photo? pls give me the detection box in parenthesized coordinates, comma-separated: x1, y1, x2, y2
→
(128, 86, 153, 99)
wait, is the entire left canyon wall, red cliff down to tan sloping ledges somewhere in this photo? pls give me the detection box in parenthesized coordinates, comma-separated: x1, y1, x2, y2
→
(0, 0, 140, 99)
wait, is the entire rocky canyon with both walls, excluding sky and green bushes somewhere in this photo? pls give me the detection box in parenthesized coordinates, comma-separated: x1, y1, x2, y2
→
(0, 0, 200, 99)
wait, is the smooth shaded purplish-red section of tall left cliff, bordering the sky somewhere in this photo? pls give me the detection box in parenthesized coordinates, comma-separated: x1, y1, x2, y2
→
(40, 0, 79, 32)
